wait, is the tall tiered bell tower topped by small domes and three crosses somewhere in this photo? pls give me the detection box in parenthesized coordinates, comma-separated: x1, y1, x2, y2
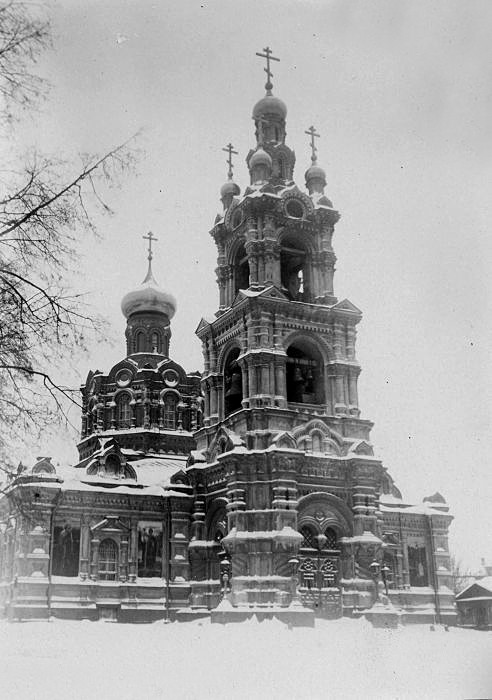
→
(190, 48, 398, 610)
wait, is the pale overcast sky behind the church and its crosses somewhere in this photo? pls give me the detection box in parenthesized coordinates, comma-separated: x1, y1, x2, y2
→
(17, 0, 492, 568)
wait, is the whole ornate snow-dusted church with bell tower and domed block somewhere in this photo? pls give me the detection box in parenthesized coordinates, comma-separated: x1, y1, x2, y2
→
(0, 48, 456, 624)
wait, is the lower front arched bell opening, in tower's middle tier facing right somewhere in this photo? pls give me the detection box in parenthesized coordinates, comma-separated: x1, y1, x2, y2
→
(286, 340, 325, 404)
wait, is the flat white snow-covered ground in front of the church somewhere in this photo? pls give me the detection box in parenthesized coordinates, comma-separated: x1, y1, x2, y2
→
(0, 619, 492, 700)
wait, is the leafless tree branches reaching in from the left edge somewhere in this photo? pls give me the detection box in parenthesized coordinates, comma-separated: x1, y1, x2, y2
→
(0, 0, 139, 474)
